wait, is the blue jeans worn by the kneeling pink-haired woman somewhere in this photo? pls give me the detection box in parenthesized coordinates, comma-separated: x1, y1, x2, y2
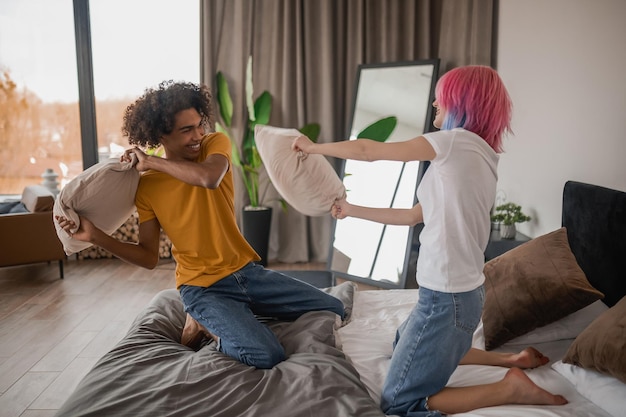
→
(381, 286, 485, 417)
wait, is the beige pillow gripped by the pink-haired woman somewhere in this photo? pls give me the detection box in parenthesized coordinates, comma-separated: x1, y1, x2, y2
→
(255, 125, 346, 216)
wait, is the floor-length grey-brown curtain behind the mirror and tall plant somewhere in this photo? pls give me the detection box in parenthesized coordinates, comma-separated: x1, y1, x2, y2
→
(201, 0, 497, 263)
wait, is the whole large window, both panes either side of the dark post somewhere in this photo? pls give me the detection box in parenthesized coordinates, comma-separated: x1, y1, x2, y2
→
(0, 0, 200, 194)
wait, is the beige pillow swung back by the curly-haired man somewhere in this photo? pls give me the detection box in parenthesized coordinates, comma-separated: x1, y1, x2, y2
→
(53, 158, 139, 255)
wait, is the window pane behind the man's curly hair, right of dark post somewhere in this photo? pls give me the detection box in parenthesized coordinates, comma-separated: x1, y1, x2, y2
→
(89, 0, 200, 160)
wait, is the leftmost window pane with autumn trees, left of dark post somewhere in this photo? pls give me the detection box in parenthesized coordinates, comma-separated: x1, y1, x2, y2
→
(0, 0, 82, 194)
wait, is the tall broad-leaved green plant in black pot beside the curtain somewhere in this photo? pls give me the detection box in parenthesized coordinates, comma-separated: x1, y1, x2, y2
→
(215, 57, 320, 265)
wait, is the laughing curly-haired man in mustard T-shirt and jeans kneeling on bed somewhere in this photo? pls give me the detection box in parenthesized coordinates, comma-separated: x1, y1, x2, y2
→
(58, 81, 344, 368)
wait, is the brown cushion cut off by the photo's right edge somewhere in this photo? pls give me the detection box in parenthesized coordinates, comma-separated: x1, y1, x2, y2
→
(563, 297, 626, 383)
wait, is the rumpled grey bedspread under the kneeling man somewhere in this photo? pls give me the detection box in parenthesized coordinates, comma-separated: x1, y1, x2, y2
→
(57, 283, 384, 417)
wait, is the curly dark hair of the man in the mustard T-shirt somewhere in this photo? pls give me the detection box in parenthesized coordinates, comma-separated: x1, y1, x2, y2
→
(122, 80, 215, 148)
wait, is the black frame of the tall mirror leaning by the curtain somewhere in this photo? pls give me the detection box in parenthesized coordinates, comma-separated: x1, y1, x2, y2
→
(327, 59, 439, 289)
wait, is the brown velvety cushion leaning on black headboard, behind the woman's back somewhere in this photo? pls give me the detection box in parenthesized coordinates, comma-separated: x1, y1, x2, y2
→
(483, 227, 604, 350)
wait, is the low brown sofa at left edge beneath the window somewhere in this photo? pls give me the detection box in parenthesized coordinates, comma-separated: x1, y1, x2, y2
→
(0, 185, 66, 278)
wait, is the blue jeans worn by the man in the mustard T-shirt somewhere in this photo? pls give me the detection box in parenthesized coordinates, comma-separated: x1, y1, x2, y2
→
(180, 263, 344, 369)
